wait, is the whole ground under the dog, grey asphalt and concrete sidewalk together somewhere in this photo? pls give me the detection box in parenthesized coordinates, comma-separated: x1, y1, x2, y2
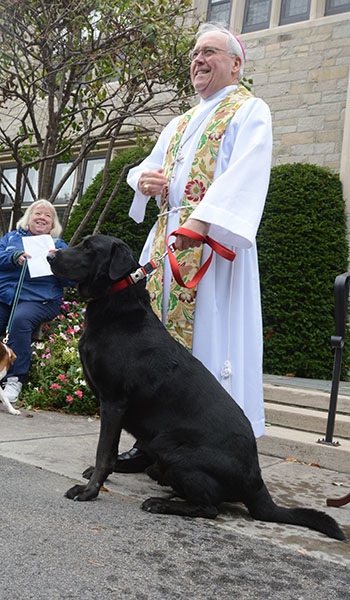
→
(0, 407, 350, 600)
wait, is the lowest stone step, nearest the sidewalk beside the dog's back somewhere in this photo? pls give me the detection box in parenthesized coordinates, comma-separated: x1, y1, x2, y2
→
(257, 425, 350, 476)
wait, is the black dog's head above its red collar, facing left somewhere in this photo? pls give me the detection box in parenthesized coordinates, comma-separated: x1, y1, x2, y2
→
(47, 235, 139, 299)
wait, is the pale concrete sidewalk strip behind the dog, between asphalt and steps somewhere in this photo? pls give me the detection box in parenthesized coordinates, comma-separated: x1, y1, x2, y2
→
(0, 406, 350, 566)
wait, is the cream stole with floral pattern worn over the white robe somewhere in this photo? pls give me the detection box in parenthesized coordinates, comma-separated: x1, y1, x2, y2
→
(147, 85, 252, 351)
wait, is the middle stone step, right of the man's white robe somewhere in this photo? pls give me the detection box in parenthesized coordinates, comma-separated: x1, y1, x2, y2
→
(265, 401, 350, 440)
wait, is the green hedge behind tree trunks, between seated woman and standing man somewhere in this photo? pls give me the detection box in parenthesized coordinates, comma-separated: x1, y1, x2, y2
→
(64, 147, 158, 256)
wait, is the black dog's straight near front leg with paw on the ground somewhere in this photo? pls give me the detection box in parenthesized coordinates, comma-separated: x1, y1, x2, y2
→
(65, 402, 124, 502)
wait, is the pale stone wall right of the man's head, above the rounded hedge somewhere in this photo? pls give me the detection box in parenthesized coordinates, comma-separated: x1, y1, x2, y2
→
(240, 13, 350, 206)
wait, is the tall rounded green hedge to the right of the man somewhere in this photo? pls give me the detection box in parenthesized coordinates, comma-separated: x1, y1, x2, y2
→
(257, 164, 349, 379)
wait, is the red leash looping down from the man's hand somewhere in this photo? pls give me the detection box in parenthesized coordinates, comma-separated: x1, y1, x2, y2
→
(166, 227, 236, 289)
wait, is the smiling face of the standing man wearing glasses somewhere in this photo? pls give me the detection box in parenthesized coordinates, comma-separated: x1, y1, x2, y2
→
(191, 32, 241, 98)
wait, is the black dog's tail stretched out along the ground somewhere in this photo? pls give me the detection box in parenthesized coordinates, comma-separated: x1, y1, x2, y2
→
(245, 483, 346, 540)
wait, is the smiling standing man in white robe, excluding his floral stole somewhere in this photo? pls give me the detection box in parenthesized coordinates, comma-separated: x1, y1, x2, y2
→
(119, 24, 272, 471)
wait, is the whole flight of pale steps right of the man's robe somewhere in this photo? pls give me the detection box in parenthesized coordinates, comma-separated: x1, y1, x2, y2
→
(258, 375, 350, 473)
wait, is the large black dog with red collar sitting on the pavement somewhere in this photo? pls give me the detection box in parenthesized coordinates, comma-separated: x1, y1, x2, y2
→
(48, 235, 345, 540)
